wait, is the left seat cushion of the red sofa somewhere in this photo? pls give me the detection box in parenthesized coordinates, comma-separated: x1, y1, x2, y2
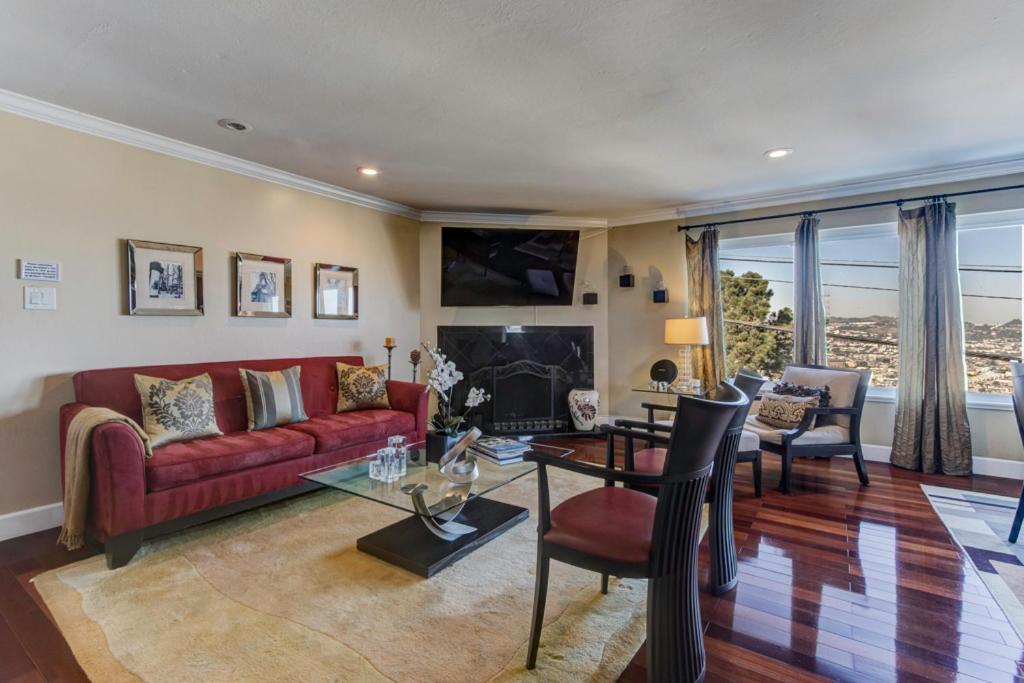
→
(145, 427, 315, 490)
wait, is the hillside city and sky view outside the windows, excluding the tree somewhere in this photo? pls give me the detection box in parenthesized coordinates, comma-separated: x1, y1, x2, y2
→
(720, 224, 1024, 393)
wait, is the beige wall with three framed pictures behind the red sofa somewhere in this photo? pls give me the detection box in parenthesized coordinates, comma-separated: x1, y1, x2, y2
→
(0, 114, 420, 514)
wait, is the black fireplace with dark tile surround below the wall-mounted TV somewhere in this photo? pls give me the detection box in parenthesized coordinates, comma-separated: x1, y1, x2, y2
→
(437, 326, 594, 434)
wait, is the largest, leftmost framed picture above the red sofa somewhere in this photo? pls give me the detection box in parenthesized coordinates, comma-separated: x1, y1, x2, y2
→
(128, 240, 203, 315)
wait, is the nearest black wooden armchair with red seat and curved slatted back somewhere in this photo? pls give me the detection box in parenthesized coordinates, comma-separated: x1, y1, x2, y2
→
(525, 385, 746, 683)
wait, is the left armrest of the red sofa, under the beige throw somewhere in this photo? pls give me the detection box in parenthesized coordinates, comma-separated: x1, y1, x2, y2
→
(60, 403, 145, 541)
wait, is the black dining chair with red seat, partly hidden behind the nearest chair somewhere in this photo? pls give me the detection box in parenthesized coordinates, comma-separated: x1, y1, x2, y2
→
(608, 374, 767, 595)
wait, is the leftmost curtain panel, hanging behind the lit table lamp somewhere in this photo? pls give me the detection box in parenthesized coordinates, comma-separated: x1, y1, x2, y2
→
(686, 227, 725, 387)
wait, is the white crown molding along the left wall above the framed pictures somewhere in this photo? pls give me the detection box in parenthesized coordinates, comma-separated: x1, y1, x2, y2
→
(0, 89, 420, 220)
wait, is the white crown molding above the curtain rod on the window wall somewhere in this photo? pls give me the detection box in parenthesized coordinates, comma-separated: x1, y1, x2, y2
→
(608, 157, 1024, 227)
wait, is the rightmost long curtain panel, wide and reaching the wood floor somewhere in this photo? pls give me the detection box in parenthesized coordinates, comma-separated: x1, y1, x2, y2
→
(891, 202, 972, 475)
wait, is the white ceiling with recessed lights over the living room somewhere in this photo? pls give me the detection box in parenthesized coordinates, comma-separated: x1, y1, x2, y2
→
(0, 0, 1024, 217)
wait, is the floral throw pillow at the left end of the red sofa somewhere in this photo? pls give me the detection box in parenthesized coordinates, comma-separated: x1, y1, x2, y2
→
(135, 373, 223, 449)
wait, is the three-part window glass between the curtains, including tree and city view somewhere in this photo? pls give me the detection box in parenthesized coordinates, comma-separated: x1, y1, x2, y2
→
(719, 211, 1024, 393)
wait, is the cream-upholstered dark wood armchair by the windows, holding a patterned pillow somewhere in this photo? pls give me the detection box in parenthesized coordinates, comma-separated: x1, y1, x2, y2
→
(745, 366, 871, 494)
